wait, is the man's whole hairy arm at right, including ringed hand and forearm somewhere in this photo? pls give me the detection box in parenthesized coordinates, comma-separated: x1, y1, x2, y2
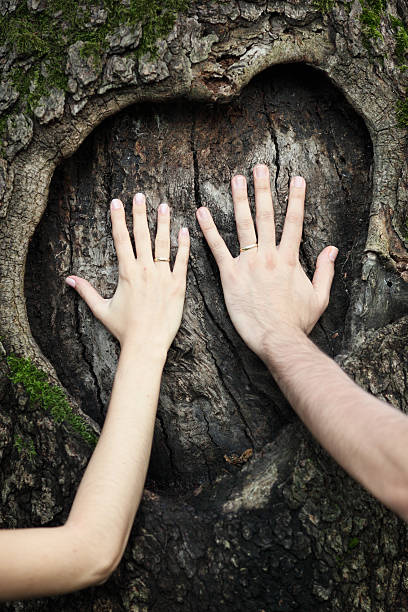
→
(197, 165, 408, 520)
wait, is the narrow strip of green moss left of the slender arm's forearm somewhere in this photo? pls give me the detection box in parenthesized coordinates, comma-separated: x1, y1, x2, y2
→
(7, 355, 98, 446)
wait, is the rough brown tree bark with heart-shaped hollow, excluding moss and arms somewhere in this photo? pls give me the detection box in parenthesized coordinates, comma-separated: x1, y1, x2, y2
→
(0, 0, 408, 612)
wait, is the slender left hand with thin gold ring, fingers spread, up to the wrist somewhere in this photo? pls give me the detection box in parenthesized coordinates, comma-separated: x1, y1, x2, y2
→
(66, 193, 190, 352)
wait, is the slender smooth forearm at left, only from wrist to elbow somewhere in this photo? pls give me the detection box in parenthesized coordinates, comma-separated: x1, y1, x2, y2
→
(67, 345, 166, 571)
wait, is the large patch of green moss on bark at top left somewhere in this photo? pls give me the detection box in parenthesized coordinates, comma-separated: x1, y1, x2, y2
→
(0, 0, 190, 144)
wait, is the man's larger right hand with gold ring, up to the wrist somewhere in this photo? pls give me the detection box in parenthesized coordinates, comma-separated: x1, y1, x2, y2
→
(197, 164, 337, 359)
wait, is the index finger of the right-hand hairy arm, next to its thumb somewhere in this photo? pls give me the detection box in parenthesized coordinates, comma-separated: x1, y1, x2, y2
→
(279, 176, 306, 259)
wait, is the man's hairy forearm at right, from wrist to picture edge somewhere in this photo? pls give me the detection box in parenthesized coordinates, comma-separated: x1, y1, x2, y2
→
(264, 331, 408, 519)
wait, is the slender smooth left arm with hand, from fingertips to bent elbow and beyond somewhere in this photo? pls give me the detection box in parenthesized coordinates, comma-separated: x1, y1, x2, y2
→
(0, 197, 189, 600)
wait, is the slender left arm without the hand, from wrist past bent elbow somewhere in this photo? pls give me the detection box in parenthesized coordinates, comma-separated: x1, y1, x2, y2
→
(0, 345, 166, 600)
